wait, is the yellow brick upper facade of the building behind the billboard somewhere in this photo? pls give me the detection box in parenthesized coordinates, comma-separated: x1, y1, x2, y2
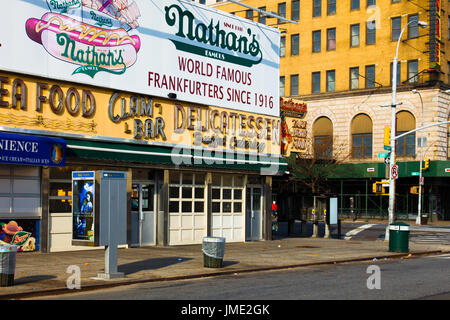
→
(206, 0, 449, 98)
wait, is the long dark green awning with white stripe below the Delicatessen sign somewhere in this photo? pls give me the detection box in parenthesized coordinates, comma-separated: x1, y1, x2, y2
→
(67, 139, 287, 175)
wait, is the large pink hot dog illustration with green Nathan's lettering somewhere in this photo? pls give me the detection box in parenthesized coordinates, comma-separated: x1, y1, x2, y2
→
(25, 12, 141, 77)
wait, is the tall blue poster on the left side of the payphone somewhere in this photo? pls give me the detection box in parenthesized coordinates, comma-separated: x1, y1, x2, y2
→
(72, 171, 95, 243)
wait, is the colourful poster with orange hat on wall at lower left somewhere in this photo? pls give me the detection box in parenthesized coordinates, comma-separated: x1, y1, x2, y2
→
(0, 219, 40, 252)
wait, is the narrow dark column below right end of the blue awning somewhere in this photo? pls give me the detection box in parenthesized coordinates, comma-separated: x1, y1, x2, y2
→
(39, 167, 50, 253)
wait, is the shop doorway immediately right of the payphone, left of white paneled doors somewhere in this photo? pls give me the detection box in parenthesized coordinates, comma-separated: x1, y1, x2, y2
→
(131, 182, 156, 246)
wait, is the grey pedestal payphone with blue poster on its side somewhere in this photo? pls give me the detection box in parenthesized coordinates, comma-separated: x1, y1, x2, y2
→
(72, 170, 127, 279)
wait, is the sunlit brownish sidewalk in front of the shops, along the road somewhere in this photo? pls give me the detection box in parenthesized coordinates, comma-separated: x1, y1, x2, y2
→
(0, 237, 450, 299)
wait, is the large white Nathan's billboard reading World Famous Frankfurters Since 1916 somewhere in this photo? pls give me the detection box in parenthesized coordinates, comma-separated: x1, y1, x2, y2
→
(0, 0, 280, 116)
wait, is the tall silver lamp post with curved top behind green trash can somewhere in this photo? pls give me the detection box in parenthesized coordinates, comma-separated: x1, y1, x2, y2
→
(385, 20, 428, 240)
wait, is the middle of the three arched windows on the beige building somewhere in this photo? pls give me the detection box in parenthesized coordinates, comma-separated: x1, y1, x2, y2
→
(351, 113, 372, 159)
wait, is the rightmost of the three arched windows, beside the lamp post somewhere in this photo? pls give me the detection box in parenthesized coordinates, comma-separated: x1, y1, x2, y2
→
(395, 111, 416, 157)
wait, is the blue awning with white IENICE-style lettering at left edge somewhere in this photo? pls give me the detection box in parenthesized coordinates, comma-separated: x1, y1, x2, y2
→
(0, 132, 66, 167)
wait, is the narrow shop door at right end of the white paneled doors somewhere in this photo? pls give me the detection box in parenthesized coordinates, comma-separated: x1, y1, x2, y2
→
(245, 186, 262, 241)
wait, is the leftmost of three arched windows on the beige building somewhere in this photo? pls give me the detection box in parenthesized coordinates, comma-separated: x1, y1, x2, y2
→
(313, 117, 333, 159)
